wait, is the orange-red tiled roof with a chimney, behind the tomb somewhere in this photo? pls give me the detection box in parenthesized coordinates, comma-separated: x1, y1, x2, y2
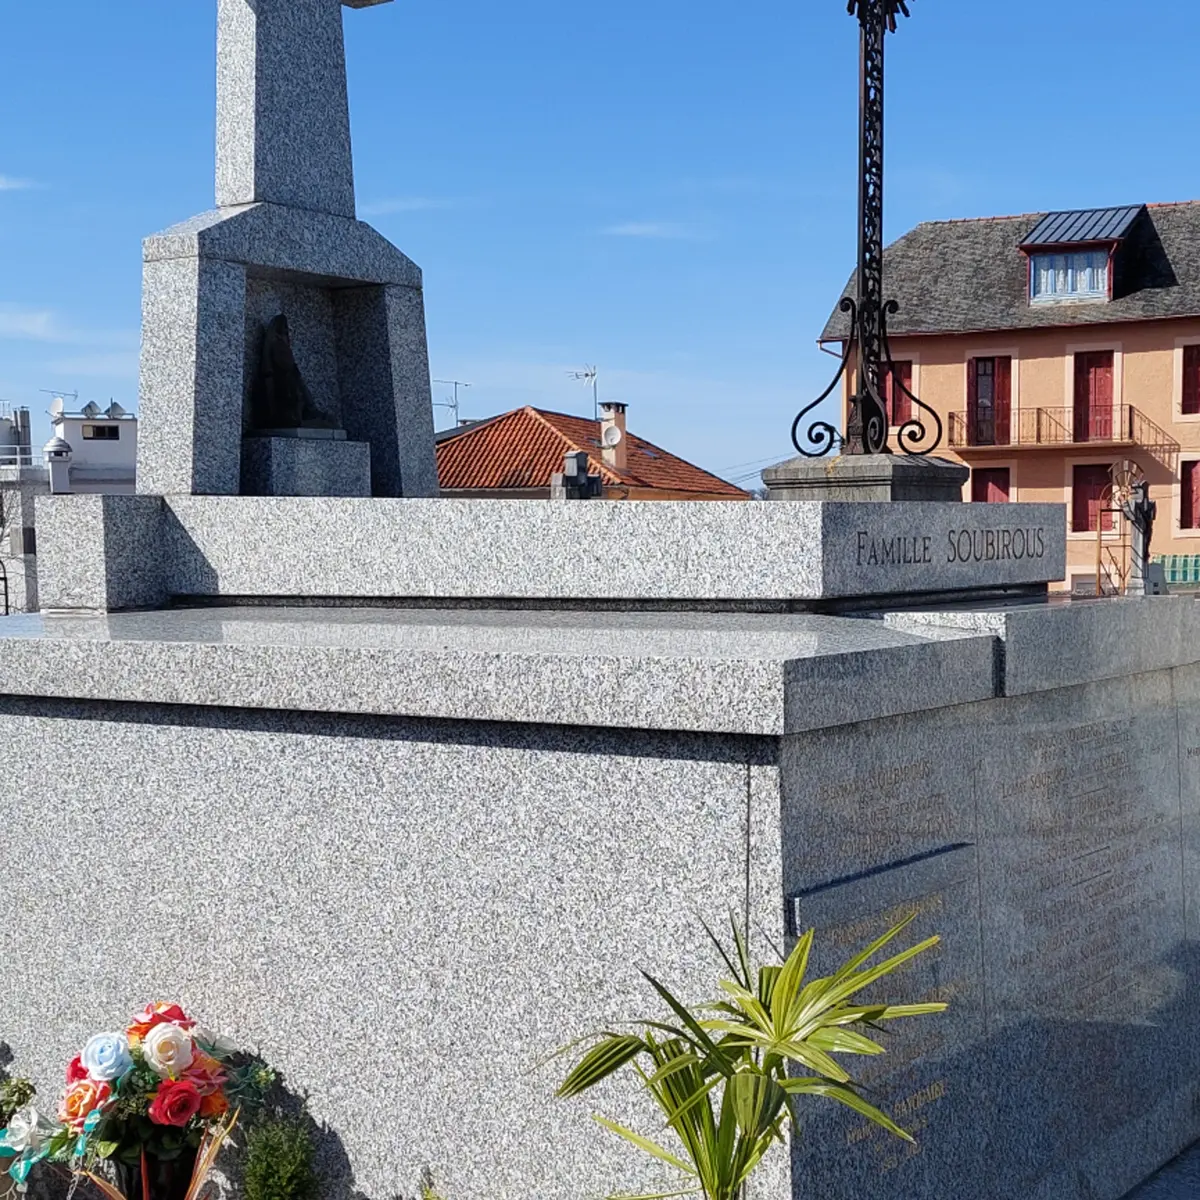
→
(437, 406, 746, 500)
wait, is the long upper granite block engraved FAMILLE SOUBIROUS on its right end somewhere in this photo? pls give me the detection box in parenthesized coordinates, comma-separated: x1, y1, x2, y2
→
(145, 496, 1066, 602)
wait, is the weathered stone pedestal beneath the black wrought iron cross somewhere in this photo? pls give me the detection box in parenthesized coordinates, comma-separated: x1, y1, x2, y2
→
(762, 454, 971, 503)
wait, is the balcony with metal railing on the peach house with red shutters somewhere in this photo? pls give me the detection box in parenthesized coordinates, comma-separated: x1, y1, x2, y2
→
(947, 404, 1180, 461)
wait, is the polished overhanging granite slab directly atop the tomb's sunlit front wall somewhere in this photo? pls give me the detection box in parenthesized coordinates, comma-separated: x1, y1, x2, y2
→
(0, 607, 995, 736)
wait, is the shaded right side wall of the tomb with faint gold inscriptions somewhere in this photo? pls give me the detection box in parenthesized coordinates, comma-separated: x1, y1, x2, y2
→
(781, 667, 1200, 1200)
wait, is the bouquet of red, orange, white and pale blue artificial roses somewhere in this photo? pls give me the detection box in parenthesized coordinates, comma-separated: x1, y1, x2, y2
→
(0, 1004, 275, 1200)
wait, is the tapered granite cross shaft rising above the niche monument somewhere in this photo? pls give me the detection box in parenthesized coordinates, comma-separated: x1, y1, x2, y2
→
(216, 0, 390, 217)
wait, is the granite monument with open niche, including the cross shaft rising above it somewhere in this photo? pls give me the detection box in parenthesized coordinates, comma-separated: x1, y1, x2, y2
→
(138, 0, 438, 497)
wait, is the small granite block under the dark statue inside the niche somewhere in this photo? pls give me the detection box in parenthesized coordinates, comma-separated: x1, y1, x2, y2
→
(241, 431, 371, 497)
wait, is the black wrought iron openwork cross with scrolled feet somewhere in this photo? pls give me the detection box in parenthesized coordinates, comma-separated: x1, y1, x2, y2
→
(792, 0, 942, 458)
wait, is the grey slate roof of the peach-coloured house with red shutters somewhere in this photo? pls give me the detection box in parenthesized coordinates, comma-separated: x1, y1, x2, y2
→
(821, 200, 1200, 341)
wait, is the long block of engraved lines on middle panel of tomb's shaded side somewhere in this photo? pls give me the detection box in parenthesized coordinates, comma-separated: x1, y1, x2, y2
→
(979, 682, 1182, 1021)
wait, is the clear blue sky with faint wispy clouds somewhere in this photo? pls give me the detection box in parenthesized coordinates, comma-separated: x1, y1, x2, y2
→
(0, 0, 1200, 487)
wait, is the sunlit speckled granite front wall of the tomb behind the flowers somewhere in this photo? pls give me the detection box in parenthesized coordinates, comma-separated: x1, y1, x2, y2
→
(0, 698, 786, 1200)
